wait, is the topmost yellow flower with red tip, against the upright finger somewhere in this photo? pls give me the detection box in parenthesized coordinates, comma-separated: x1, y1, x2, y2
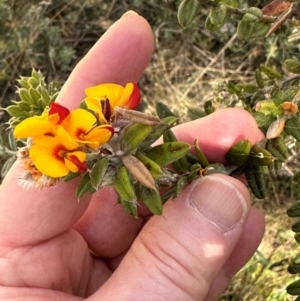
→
(85, 83, 141, 124)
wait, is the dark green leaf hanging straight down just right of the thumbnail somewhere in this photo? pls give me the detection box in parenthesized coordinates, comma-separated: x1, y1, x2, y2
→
(245, 164, 266, 199)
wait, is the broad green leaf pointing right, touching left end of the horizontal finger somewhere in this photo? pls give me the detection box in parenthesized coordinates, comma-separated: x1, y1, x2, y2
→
(146, 142, 190, 166)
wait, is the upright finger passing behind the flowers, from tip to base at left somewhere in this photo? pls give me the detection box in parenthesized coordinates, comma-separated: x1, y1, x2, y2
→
(0, 14, 153, 246)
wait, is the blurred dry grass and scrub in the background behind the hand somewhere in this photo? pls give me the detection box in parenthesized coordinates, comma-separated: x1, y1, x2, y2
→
(0, 0, 299, 301)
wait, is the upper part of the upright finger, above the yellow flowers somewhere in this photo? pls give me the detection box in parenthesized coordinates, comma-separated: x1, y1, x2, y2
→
(56, 11, 154, 109)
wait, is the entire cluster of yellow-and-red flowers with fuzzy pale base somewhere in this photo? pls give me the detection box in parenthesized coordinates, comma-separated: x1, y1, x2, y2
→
(14, 83, 140, 186)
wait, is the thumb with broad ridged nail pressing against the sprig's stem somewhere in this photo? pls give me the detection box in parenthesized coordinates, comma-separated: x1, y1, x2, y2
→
(88, 175, 263, 301)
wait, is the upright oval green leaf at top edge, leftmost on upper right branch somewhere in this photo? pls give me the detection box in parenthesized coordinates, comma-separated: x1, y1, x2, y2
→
(177, 0, 200, 27)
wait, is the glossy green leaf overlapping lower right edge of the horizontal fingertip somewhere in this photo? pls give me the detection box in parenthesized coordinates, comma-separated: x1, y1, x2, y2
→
(226, 139, 251, 167)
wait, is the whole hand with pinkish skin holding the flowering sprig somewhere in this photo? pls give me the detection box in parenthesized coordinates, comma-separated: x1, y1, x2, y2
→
(0, 12, 264, 301)
